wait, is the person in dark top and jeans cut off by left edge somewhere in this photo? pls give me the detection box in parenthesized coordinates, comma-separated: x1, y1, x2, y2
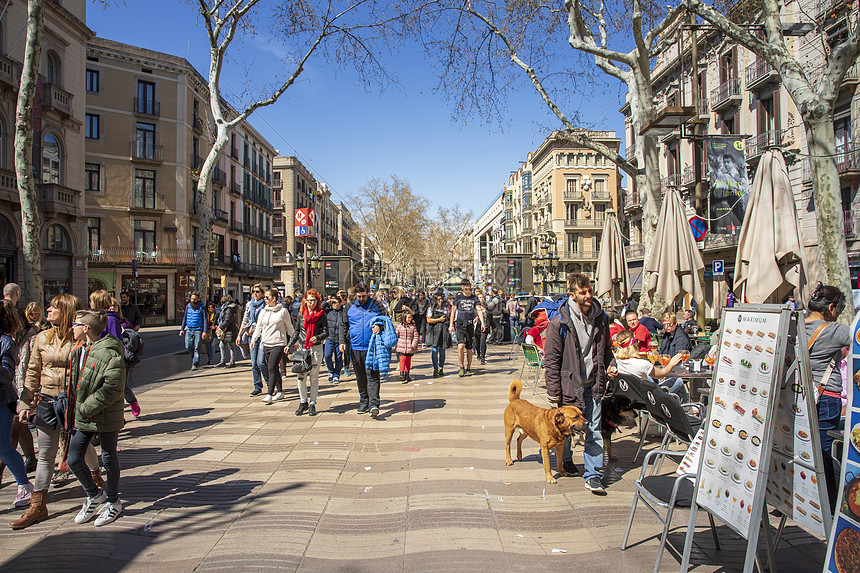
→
(0, 300, 33, 507)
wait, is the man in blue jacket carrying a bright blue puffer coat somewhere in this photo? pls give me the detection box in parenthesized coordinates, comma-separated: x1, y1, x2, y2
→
(338, 282, 385, 418)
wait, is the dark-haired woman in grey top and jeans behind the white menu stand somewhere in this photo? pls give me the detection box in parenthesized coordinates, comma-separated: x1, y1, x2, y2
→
(806, 283, 851, 511)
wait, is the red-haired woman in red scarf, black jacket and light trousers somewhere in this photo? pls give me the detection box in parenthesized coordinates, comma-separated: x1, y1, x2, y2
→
(290, 289, 328, 416)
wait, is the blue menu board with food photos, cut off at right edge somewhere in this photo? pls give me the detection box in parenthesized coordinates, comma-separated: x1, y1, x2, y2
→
(824, 310, 860, 573)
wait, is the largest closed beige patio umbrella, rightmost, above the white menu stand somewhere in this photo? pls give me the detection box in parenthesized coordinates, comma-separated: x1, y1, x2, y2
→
(735, 149, 807, 303)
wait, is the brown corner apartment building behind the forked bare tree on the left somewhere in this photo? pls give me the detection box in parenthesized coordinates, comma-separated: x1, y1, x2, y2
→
(79, 38, 275, 325)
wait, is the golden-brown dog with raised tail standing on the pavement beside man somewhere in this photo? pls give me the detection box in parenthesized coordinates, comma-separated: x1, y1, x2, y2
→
(505, 380, 588, 483)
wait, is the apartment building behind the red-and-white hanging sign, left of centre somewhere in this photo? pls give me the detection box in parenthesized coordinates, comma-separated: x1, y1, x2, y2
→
(273, 156, 361, 295)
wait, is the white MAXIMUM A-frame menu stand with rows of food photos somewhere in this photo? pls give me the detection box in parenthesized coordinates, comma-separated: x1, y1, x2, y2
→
(681, 304, 830, 573)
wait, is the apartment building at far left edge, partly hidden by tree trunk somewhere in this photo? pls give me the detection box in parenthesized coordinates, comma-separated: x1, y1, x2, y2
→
(0, 0, 94, 301)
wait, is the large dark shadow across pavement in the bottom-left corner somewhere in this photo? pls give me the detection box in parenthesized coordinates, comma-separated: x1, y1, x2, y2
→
(0, 468, 305, 573)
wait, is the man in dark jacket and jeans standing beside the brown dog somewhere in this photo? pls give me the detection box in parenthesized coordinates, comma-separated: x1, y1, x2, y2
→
(544, 273, 614, 495)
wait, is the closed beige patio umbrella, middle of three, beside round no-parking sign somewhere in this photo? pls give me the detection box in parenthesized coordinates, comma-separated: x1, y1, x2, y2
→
(645, 189, 705, 304)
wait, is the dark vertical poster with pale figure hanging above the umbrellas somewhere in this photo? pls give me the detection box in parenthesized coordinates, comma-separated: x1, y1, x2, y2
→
(705, 137, 749, 235)
